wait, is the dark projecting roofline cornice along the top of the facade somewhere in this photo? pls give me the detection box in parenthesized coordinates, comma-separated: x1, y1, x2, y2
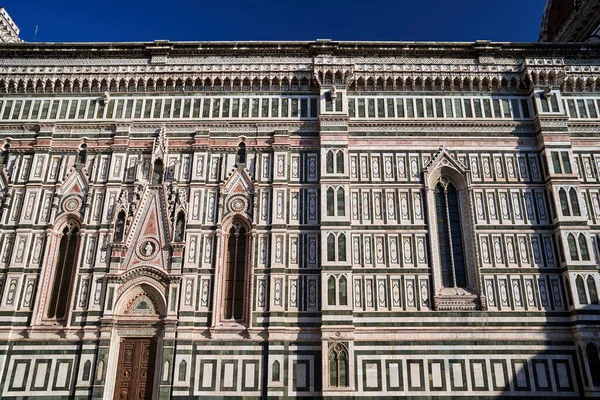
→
(0, 39, 600, 58)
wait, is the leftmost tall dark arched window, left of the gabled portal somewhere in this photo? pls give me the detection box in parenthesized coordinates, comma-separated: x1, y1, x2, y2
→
(48, 222, 79, 320)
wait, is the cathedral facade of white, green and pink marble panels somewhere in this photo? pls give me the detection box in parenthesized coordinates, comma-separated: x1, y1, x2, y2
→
(0, 5, 600, 399)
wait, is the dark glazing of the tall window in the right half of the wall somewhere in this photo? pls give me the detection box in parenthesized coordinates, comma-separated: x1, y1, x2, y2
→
(435, 181, 467, 288)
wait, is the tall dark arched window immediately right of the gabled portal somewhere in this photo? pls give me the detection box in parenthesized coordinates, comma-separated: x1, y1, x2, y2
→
(223, 222, 246, 320)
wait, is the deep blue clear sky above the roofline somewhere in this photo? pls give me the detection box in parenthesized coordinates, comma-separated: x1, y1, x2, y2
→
(0, 0, 545, 42)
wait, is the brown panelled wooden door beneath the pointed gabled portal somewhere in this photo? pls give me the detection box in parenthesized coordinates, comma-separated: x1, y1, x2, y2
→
(113, 338, 156, 400)
